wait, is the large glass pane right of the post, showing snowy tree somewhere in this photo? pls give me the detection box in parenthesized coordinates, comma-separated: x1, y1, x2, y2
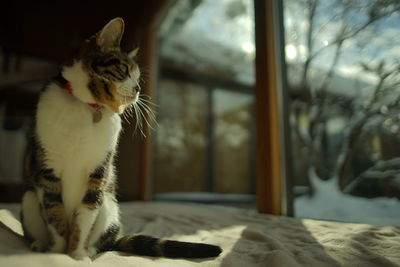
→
(284, 0, 400, 225)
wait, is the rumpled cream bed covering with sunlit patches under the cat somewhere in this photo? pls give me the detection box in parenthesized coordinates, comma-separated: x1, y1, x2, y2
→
(0, 202, 400, 267)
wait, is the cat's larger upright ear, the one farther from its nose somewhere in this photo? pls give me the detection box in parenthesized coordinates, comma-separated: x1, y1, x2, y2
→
(96, 18, 125, 50)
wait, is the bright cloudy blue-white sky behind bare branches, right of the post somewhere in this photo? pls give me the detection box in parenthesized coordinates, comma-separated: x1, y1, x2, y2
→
(284, 0, 400, 87)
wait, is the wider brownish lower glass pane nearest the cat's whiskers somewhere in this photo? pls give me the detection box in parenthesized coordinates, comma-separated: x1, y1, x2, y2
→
(154, 79, 209, 193)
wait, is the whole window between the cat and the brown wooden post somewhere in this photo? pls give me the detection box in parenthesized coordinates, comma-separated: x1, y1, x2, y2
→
(152, 0, 255, 205)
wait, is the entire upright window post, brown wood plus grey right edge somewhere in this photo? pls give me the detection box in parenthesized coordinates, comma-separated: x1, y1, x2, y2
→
(254, 0, 292, 215)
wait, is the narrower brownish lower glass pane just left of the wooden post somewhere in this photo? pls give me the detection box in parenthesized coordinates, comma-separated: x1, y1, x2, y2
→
(213, 89, 255, 194)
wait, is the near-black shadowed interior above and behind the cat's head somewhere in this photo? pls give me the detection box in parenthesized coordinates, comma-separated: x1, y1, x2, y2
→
(0, 0, 163, 63)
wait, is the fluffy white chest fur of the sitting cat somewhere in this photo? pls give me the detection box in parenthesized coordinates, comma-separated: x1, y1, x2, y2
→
(37, 86, 121, 175)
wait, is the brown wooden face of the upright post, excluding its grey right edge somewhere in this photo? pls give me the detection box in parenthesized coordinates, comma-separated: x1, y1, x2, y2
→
(254, 0, 282, 215)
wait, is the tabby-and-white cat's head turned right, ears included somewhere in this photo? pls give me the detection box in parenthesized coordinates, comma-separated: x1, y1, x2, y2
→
(62, 18, 140, 113)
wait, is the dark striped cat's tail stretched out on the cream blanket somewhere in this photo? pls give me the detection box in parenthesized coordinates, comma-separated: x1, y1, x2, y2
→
(114, 235, 222, 258)
